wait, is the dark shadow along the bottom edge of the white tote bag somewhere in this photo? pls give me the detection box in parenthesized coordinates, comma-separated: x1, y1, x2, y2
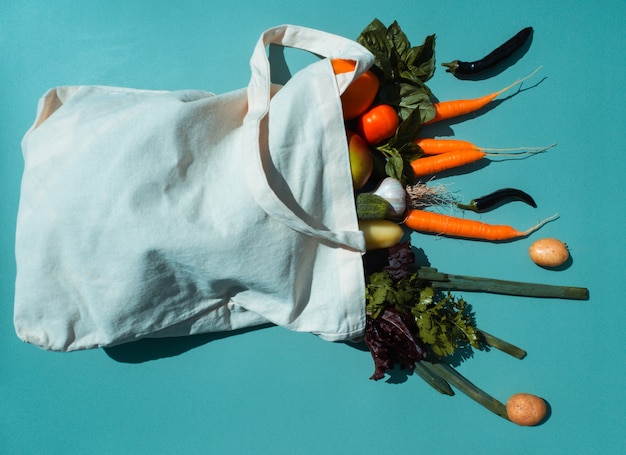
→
(104, 324, 274, 363)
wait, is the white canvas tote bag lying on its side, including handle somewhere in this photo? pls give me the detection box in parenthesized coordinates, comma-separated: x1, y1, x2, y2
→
(14, 25, 373, 351)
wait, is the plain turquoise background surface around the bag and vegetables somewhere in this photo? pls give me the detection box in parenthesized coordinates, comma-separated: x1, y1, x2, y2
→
(0, 0, 626, 455)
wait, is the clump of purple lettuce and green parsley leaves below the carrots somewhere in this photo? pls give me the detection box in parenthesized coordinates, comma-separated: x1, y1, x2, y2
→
(365, 241, 483, 379)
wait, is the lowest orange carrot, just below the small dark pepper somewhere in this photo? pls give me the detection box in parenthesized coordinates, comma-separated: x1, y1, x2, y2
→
(404, 209, 558, 241)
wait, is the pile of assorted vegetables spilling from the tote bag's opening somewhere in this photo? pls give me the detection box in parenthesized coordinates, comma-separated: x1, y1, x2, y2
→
(333, 19, 588, 425)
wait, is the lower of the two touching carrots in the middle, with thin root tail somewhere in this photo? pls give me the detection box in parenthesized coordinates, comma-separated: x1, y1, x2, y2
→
(411, 144, 554, 177)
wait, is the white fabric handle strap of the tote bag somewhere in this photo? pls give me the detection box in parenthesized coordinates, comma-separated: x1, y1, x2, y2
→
(245, 25, 373, 251)
